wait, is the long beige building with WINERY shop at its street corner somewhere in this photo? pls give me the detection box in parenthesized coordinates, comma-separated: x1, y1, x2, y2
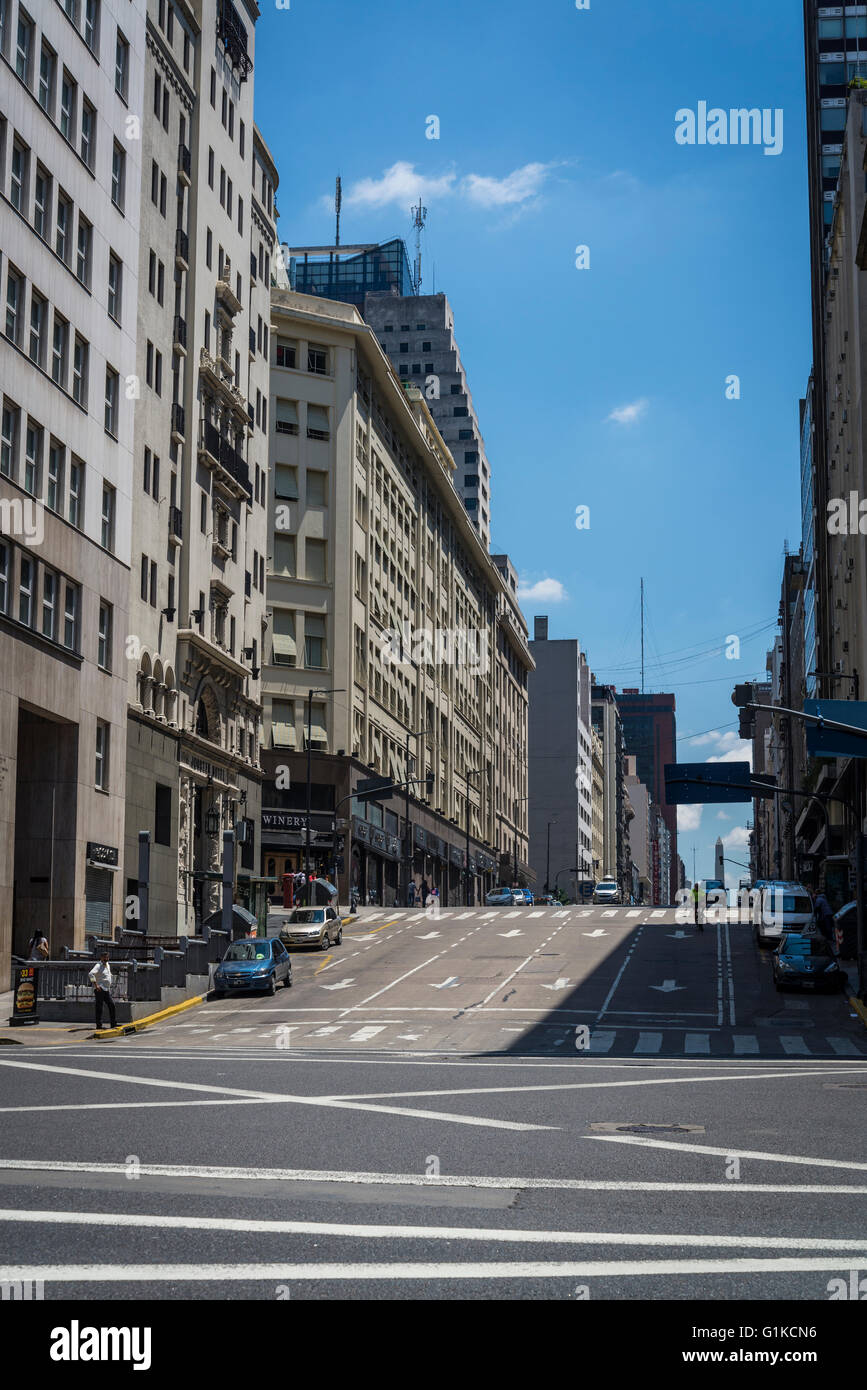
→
(263, 289, 532, 904)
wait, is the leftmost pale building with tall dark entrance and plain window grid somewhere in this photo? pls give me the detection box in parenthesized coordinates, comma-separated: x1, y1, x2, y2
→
(0, 0, 145, 977)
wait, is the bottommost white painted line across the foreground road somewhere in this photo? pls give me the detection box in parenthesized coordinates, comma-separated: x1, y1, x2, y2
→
(8, 1262, 864, 1284)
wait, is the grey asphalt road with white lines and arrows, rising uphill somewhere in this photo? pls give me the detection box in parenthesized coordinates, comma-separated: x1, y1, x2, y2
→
(0, 908, 867, 1301)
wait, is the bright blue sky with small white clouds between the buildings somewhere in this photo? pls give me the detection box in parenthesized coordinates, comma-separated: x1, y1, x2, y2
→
(256, 0, 811, 883)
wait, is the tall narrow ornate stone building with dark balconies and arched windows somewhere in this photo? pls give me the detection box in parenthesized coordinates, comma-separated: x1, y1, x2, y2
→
(121, 0, 276, 931)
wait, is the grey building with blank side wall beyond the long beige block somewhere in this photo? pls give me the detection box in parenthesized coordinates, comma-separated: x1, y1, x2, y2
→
(529, 617, 593, 895)
